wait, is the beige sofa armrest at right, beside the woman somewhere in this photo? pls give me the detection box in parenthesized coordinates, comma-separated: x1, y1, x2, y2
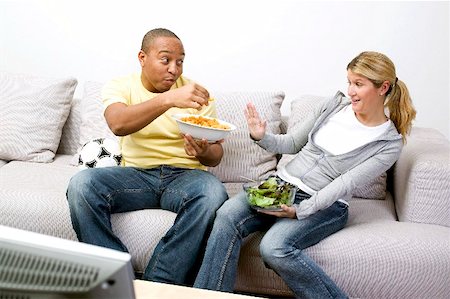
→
(393, 127, 450, 227)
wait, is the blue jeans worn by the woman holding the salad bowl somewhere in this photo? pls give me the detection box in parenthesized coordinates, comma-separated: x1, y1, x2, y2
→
(194, 191, 348, 298)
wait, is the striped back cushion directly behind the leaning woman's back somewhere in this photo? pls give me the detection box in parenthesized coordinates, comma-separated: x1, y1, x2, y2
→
(278, 95, 387, 199)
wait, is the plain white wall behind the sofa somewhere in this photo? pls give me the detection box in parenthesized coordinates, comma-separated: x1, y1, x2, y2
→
(0, 0, 450, 137)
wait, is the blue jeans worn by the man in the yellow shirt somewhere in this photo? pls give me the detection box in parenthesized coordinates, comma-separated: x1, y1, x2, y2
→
(67, 165, 228, 285)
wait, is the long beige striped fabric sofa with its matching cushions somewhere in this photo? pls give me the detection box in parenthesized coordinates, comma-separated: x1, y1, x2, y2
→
(0, 73, 450, 298)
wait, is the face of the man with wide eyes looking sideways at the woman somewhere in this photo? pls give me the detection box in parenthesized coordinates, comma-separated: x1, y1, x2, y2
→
(138, 37, 184, 93)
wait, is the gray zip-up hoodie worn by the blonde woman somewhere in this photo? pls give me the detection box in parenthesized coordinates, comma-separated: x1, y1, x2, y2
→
(257, 92, 403, 219)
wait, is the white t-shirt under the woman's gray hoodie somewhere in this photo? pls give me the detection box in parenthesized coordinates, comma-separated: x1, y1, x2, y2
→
(313, 105, 391, 155)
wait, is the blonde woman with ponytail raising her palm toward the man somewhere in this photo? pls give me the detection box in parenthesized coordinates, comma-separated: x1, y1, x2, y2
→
(195, 52, 416, 298)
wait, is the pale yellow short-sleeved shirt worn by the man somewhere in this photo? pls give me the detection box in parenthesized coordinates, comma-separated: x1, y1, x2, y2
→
(102, 74, 217, 169)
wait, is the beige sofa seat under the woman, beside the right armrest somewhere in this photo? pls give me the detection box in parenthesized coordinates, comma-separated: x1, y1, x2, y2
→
(235, 196, 450, 298)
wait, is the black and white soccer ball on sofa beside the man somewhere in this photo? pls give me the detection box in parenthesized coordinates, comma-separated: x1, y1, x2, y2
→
(78, 138, 122, 169)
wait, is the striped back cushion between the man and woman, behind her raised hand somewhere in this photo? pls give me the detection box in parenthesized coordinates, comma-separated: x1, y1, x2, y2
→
(209, 92, 284, 182)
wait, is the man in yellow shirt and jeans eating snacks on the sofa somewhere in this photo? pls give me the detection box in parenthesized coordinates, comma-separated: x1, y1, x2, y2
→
(67, 29, 227, 285)
